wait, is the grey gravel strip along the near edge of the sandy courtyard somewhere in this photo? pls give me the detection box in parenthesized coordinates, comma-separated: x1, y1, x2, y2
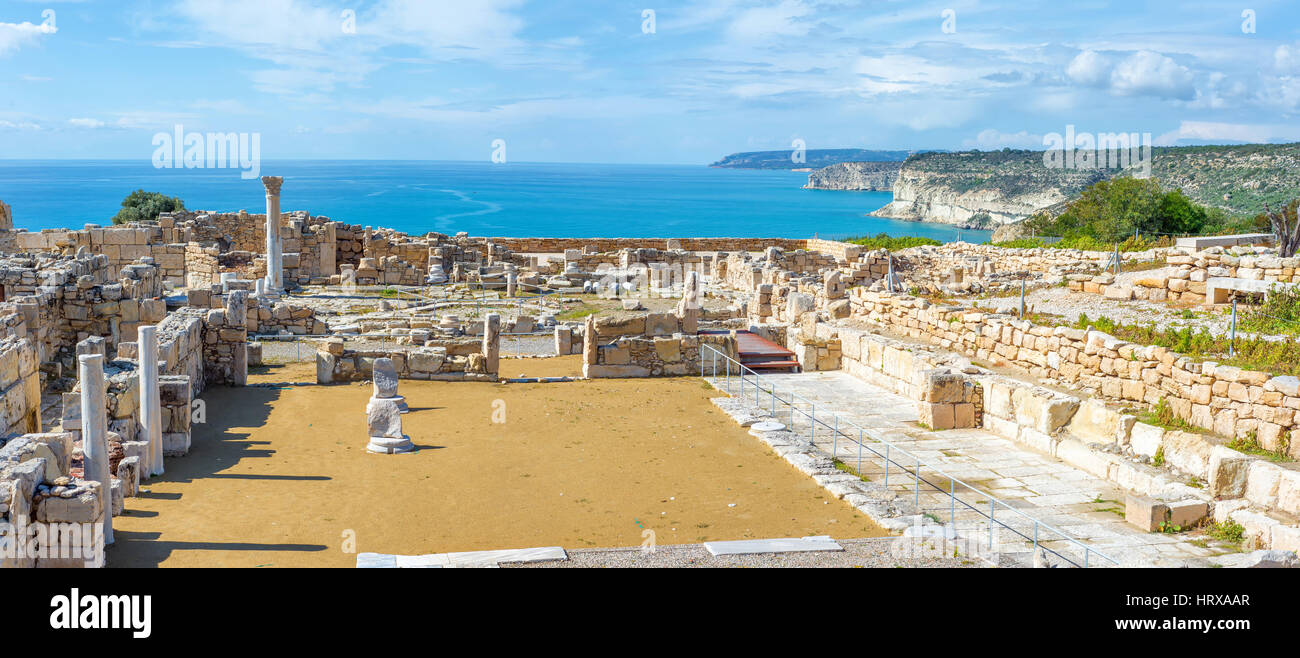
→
(502, 537, 988, 568)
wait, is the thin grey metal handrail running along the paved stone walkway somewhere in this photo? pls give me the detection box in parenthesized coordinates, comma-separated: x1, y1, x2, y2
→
(699, 345, 1119, 568)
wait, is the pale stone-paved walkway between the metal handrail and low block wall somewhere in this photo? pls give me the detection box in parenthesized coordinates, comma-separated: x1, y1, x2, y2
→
(714, 371, 1225, 566)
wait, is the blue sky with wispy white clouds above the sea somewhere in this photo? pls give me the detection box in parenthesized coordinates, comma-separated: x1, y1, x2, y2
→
(0, 0, 1300, 164)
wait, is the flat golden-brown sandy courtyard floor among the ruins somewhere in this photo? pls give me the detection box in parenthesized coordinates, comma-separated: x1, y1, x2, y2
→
(108, 356, 884, 567)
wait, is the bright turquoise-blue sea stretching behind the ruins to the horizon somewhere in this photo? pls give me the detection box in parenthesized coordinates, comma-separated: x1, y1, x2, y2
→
(0, 160, 989, 242)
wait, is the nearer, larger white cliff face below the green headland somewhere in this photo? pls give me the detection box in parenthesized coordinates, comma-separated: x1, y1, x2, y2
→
(871, 168, 1067, 225)
